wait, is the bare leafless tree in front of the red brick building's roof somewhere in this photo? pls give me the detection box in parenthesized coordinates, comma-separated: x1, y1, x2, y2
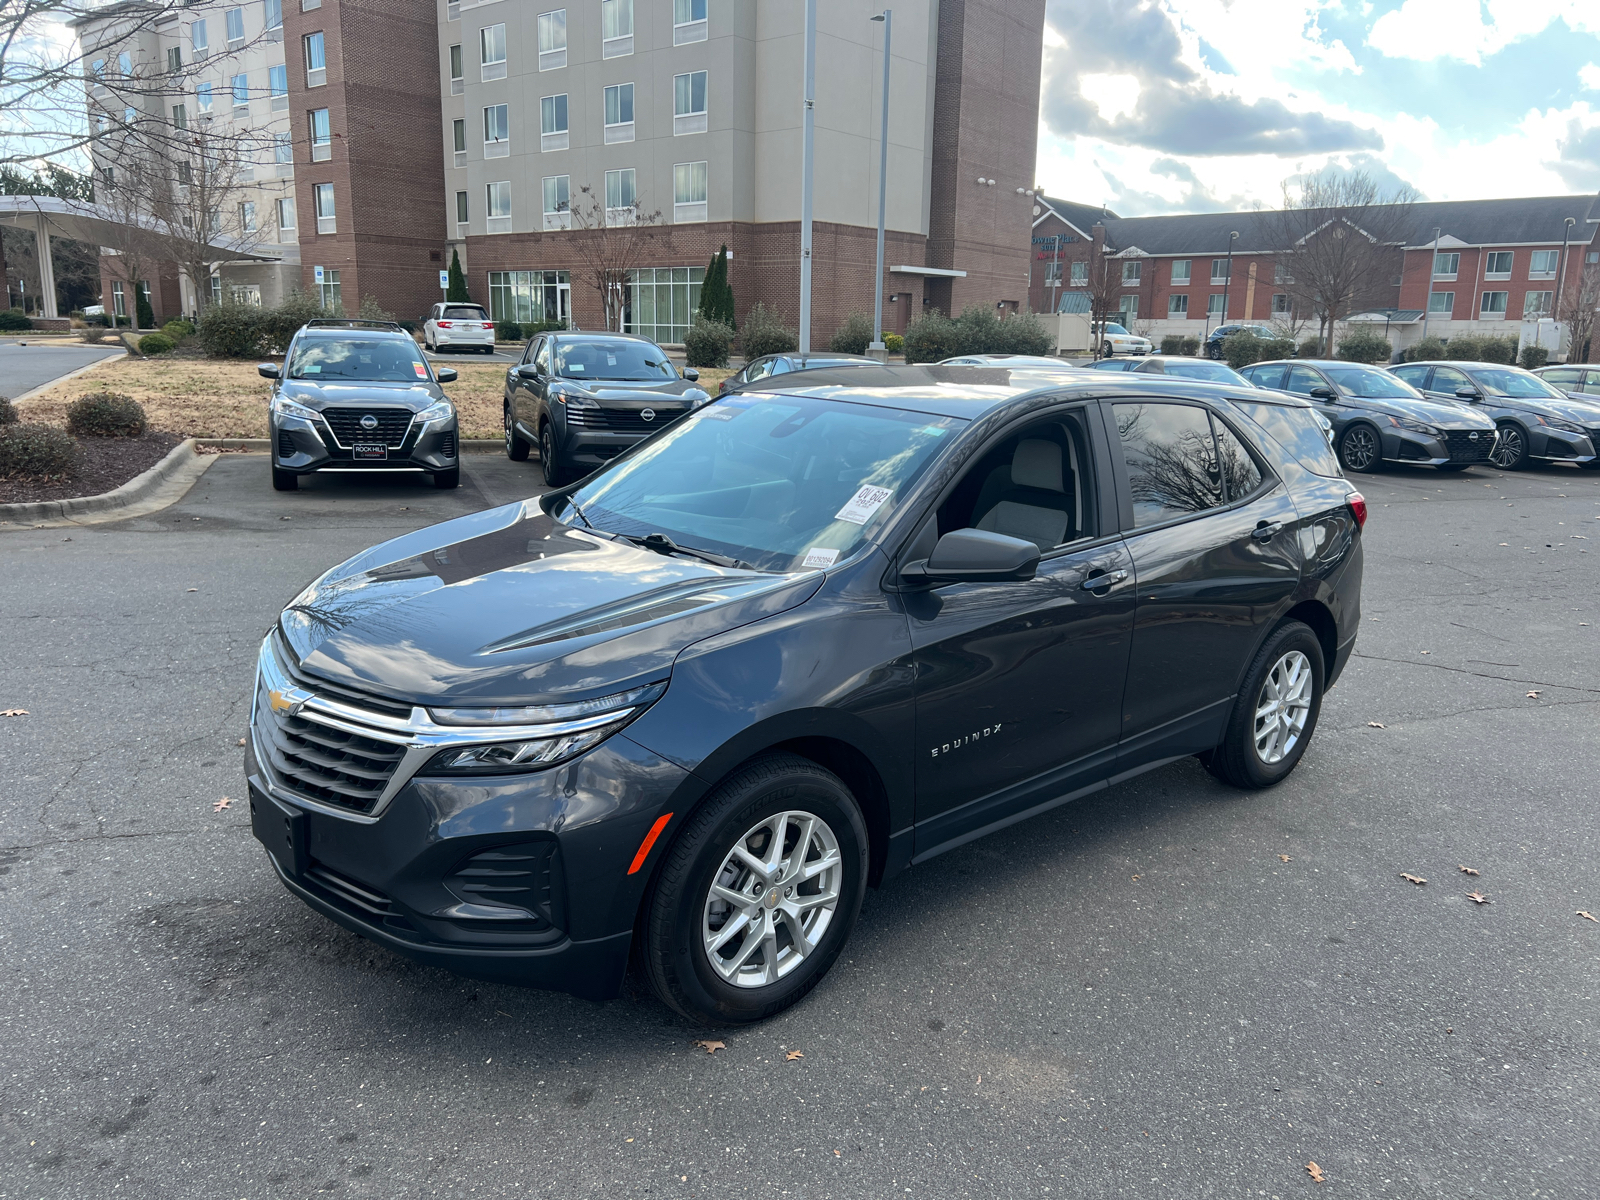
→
(1261, 171, 1416, 354)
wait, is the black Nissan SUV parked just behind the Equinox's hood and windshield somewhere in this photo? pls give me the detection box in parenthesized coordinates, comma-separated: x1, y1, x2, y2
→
(506, 333, 710, 488)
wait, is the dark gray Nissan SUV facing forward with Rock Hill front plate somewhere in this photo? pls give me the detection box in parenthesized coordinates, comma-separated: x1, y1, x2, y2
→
(256, 318, 461, 491)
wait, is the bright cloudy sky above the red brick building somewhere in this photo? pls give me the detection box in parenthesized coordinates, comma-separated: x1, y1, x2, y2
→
(1037, 0, 1600, 216)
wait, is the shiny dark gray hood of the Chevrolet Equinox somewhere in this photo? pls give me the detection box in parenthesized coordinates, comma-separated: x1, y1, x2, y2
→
(278, 499, 824, 706)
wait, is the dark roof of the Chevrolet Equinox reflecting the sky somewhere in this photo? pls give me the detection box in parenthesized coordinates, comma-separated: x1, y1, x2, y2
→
(725, 365, 1314, 419)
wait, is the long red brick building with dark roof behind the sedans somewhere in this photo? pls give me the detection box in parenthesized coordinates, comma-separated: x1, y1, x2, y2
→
(1029, 195, 1600, 358)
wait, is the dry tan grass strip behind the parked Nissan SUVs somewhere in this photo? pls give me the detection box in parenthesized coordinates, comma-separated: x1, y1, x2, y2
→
(18, 358, 733, 437)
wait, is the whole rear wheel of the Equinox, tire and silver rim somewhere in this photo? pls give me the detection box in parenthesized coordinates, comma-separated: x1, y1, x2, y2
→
(1206, 621, 1326, 789)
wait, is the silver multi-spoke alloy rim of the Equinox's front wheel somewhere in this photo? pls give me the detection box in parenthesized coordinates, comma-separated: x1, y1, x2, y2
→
(701, 811, 843, 987)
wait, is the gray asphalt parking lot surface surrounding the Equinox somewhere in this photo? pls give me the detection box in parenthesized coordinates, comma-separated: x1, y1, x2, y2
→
(0, 454, 1600, 1200)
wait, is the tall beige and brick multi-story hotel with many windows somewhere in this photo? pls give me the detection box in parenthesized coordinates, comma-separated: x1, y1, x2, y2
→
(80, 0, 1045, 342)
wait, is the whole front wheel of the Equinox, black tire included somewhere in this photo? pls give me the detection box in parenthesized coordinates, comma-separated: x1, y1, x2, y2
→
(638, 754, 869, 1024)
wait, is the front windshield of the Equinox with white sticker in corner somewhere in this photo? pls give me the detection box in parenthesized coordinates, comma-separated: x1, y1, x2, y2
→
(573, 395, 966, 571)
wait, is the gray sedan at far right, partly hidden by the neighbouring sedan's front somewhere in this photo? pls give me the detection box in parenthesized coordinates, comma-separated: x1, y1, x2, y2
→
(1389, 363, 1600, 470)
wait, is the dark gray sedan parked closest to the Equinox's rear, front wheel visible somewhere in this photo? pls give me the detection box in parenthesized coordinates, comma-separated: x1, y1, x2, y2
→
(1240, 358, 1494, 470)
